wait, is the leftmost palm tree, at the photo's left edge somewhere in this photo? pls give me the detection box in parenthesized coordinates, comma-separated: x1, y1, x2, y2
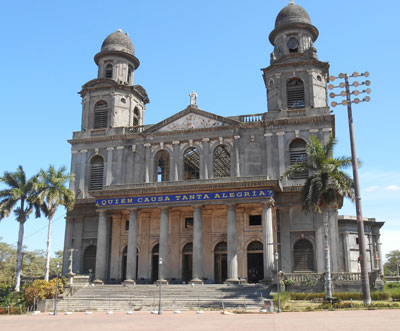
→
(0, 166, 40, 292)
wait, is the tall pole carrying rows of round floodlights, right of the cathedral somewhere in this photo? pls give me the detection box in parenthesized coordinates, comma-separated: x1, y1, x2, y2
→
(328, 71, 371, 304)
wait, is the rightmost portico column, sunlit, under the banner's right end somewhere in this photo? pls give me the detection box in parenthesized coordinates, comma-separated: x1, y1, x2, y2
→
(262, 201, 274, 282)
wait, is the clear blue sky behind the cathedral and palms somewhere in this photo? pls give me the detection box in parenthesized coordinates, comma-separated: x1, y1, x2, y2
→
(0, 0, 400, 262)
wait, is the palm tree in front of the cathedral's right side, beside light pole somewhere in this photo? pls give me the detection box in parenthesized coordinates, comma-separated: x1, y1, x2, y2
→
(284, 136, 354, 299)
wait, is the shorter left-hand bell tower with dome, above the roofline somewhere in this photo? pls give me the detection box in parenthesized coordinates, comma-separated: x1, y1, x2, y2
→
(79, 30, 149, 131)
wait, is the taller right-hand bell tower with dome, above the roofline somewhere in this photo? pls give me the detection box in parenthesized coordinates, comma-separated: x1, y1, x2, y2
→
(261, 1, 329, 112)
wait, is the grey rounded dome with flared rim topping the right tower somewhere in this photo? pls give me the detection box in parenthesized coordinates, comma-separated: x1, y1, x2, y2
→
(269, 2, 318, 45)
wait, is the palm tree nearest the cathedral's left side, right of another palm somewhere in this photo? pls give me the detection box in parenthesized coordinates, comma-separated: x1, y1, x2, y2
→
(39, 165, 75, 281)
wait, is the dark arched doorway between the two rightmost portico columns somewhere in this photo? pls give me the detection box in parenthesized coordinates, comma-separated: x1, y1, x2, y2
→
(247, 241, 264, 283)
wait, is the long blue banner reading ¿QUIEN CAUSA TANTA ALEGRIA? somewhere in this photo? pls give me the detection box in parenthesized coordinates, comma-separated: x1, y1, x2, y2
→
(96, 189, 273, 207)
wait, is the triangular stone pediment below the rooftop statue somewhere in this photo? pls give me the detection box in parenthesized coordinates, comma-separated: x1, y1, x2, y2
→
(146, 106, 239, 132)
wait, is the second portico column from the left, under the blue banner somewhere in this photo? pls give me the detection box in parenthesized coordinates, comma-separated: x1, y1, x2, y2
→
(125, 208, 138, 285)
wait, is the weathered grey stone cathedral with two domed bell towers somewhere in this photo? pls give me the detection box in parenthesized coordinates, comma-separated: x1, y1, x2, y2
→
(63, 2, 383, 284)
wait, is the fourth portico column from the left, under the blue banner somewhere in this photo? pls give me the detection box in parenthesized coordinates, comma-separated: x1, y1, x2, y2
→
(192, 206, 203, 284)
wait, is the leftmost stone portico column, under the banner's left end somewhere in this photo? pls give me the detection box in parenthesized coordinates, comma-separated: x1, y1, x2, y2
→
(94, 210, 107, 285)
